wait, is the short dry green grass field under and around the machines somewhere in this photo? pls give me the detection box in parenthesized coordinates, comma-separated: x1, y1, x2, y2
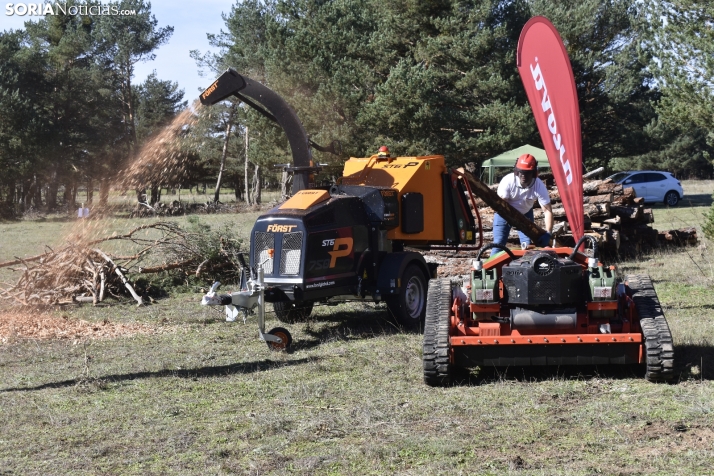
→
(0, 182, 714, 475)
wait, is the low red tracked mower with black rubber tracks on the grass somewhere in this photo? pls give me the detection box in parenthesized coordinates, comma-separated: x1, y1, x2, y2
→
(423, 236, 674, 386)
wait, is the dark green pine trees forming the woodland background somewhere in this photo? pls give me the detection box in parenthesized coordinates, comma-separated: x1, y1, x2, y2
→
(0, 0, 714, 217)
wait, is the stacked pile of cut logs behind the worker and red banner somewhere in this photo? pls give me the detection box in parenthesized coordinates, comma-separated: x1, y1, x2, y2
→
(468, 174, 698, 256)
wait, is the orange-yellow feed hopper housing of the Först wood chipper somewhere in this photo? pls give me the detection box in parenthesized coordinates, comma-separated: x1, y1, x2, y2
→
(342, 155, 446, 241)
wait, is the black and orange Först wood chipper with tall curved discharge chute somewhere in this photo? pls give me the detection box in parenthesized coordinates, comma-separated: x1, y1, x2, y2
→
(201, 70, 482, 348)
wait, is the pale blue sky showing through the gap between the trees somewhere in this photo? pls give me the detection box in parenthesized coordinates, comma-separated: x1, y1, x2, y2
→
(0, 0, 237, 104)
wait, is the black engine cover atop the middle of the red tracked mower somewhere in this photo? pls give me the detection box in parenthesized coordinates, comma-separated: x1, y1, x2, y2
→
(503, 250, 583, 306)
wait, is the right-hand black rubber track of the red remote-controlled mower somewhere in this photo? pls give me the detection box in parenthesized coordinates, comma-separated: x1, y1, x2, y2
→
(625, 274, 674, 382)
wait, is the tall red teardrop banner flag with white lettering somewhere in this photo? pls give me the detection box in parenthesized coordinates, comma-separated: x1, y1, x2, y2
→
(516, 17, 584, 241)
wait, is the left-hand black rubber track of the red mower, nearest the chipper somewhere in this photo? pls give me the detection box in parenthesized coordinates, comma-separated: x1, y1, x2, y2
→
(422, 279, 454, 387)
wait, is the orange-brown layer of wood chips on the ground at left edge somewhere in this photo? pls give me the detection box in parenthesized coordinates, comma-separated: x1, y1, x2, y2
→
(0, 311, 156, 344)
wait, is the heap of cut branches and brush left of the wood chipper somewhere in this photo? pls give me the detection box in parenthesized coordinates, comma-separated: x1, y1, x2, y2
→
(0, 222, 240, 306)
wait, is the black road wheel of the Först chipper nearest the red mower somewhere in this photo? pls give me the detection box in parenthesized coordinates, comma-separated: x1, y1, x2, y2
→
(387, 264, 428, 329)
